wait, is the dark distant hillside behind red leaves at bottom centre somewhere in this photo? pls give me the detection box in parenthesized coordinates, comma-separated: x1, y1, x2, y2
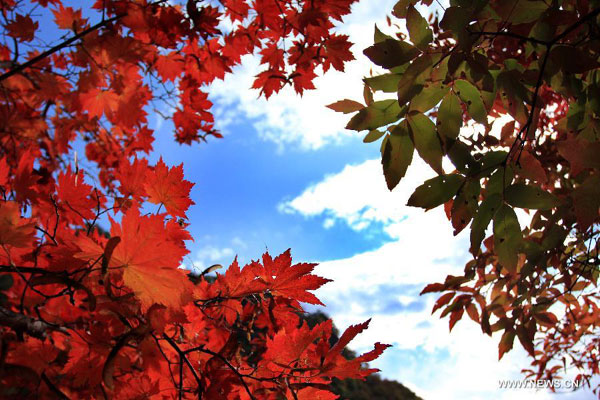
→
(304, 312, 423, 400)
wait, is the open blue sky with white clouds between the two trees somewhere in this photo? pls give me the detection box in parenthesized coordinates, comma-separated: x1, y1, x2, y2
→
(142, 0, 591, 399)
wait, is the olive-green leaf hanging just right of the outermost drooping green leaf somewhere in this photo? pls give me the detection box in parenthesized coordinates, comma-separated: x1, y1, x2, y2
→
(407, 113, 444, 174)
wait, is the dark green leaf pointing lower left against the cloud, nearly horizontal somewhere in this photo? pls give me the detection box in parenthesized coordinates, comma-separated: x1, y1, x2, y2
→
(407, 174, 465, 210)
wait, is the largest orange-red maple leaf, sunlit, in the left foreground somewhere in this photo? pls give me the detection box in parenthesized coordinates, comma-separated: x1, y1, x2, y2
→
(109, 208, 190, 310)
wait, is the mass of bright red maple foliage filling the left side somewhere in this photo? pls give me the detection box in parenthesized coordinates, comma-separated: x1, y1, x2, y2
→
(0, 0, 387, 399)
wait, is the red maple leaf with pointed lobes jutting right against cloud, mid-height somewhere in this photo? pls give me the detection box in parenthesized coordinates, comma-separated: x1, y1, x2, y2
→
(257, 249, 331, 305)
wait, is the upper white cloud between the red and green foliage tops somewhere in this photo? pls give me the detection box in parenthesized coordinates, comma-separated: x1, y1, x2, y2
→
(209, 0, 395, 149)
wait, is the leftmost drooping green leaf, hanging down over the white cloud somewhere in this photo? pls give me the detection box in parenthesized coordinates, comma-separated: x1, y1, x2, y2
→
(381, 120, 415, 190)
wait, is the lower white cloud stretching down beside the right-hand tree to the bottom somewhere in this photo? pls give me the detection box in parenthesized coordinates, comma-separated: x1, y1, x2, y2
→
(280, 160, 589, 399)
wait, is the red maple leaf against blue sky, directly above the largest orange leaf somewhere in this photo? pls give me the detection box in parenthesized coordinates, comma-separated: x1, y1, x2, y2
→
(144, 157, 194, 218)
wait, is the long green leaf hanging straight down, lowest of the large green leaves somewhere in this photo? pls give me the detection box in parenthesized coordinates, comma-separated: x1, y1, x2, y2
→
(494, 204, 523, 273)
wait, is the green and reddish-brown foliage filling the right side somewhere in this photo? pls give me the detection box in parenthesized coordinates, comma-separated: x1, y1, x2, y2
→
(336, 0, 600, 394)
